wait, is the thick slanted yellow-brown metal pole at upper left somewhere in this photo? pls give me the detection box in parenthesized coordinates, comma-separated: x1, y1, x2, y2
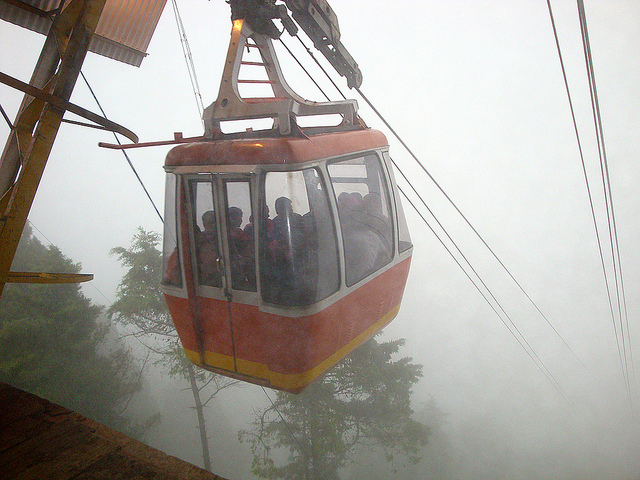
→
(0, 0, 106, 295)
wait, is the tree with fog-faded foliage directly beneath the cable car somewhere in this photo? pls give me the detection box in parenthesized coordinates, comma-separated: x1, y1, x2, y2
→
(239, 339, 430, 480)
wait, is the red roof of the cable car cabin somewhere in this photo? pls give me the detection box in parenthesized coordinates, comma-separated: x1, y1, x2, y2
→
(165, 129, 388, 168)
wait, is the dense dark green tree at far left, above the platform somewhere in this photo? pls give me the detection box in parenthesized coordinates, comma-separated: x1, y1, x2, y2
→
(0, 225, 146, 436)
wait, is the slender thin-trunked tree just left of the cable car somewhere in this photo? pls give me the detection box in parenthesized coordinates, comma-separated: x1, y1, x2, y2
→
(108, 228, 238, 471)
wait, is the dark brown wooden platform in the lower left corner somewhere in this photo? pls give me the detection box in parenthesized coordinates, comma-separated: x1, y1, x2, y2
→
(0, 383, 228, 480)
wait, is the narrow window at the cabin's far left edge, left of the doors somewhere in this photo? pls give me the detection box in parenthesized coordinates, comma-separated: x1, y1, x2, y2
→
(162, 173, 182, 287)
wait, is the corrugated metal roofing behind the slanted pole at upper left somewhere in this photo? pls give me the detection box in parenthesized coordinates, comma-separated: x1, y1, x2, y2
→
(0, 0, 167, 67)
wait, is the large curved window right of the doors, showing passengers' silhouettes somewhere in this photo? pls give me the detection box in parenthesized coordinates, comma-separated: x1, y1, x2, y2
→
(259, 168, 340, 306)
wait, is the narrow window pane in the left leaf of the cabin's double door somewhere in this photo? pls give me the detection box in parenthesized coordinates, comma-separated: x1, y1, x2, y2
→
(189, 175, 223, 287)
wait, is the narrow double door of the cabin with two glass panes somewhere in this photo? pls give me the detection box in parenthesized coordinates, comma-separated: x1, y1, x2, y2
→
(188, 173, 257, 373)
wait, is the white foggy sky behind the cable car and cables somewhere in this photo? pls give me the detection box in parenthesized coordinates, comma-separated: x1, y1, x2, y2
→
(0, 0, 640, 478)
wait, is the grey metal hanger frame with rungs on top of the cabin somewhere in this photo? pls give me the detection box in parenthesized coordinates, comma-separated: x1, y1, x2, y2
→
(203, 20, 360, 138)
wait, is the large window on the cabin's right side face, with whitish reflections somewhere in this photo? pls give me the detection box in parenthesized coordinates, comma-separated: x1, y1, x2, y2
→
(328, 153, 394, 286)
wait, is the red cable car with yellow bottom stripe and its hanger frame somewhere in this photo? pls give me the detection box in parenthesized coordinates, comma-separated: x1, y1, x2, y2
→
(162, 7, 412, 393)
